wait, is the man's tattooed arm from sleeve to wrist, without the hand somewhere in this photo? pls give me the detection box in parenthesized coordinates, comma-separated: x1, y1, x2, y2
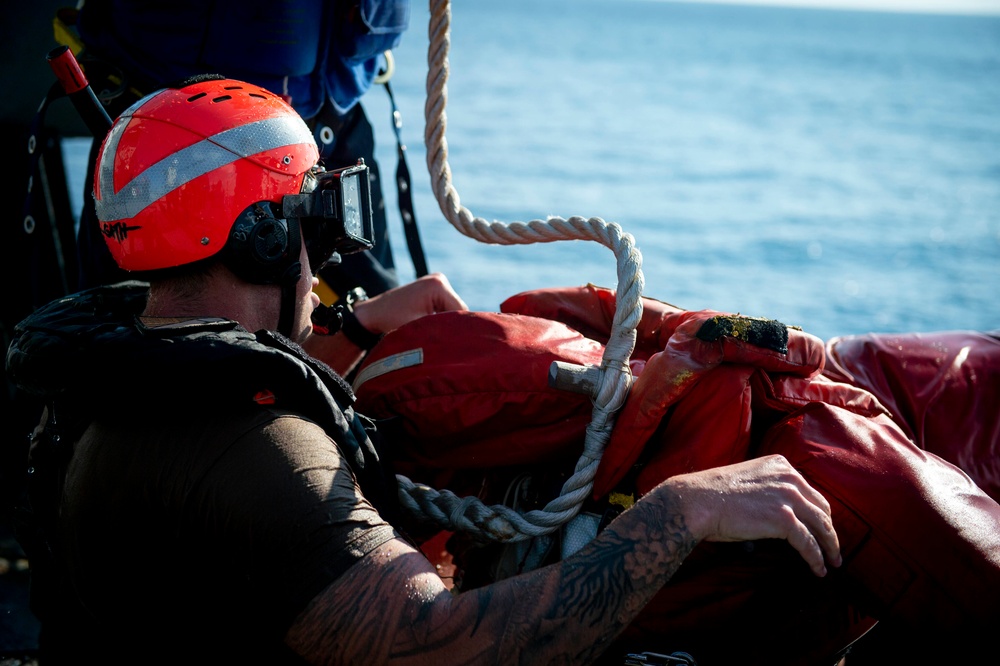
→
(286, 489, 696, 666)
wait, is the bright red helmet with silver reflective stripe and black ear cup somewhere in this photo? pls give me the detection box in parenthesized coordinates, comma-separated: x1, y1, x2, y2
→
(94, 78, 319, 276)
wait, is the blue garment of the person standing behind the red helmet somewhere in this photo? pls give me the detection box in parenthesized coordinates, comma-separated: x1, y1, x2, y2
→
(78, 0, 410, 118)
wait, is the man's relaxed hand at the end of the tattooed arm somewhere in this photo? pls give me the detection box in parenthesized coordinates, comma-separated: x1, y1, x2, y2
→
(651, 455, 841, 576)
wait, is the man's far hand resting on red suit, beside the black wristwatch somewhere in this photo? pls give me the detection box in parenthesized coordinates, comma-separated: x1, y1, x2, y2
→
(354, 273, 469, 333)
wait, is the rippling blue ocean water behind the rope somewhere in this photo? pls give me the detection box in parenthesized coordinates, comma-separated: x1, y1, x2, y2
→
(64, 0, 1000, 339)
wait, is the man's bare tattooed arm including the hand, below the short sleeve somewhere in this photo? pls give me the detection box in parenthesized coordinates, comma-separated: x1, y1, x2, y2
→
(286, 455, 841, 666)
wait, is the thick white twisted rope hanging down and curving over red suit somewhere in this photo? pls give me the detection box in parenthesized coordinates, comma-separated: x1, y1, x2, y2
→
(397, 0, 644, 543)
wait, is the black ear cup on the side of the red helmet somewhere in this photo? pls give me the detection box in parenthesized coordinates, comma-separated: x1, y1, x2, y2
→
(223, 201, 299, 284)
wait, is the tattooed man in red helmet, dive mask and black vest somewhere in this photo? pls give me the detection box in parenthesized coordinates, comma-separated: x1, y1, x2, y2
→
(7, 79, 841, 664)
